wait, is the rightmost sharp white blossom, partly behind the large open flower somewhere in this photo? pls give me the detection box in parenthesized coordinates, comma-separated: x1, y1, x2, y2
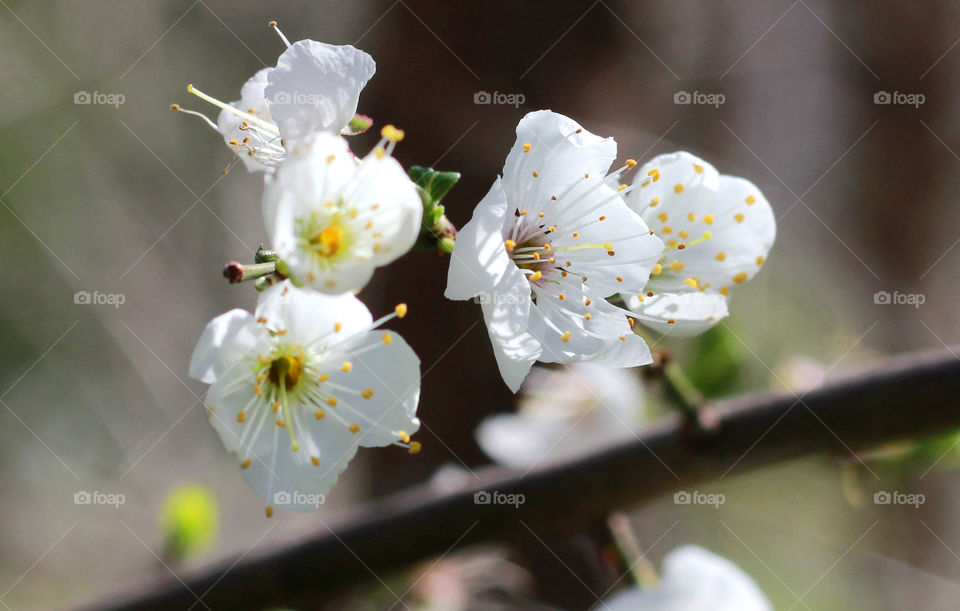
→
(627, 152, 777, 335)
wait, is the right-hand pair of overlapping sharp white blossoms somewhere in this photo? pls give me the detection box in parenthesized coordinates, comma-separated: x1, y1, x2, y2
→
(446, 110, 776, 392)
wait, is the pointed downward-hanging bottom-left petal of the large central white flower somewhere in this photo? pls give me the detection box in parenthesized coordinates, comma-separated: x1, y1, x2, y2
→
(481, 266, 541, 392)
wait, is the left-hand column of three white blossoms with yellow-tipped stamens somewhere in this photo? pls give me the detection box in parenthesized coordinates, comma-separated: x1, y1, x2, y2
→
(173, 24, 423, 517)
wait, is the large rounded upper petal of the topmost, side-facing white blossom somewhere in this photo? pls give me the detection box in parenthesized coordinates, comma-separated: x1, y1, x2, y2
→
(265, 40, 376, 141)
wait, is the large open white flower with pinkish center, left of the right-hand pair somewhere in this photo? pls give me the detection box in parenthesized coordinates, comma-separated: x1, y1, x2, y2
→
(446, 110, 663, 391)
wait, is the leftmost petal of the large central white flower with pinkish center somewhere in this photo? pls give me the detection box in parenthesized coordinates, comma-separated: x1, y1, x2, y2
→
(444, 178, 516, 299)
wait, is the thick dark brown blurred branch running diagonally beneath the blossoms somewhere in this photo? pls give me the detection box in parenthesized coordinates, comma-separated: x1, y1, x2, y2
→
(86, 352, 960, 611)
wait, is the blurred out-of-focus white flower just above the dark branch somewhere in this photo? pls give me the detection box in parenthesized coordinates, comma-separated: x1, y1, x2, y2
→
(476, 362, 644, 469)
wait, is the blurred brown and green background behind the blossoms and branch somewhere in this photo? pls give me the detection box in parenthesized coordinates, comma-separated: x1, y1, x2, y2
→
(0, 0, 960, 609)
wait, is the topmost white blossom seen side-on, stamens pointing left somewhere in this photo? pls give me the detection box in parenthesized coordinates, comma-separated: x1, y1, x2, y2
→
(173, 22, 376, 171)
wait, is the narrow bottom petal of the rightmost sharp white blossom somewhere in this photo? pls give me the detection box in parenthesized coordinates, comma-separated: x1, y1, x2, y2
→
(626, 291, 729, 337)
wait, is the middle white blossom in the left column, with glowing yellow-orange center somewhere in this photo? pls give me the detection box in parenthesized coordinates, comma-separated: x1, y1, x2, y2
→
(264, 125, 423, 294)
